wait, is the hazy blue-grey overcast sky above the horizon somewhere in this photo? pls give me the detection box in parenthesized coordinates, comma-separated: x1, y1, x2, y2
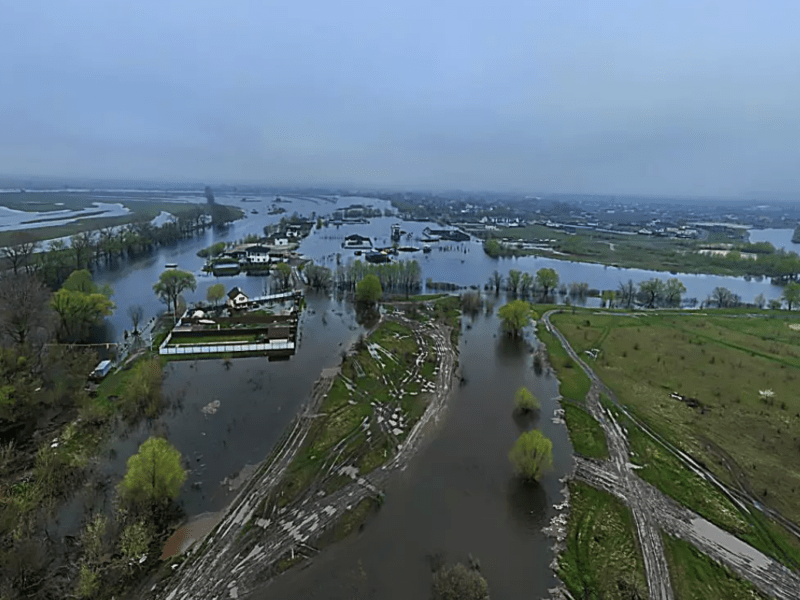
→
(0, 0, 800, 196)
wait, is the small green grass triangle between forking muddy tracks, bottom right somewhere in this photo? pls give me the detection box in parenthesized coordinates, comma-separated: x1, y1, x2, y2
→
(663, 535, 765, 600)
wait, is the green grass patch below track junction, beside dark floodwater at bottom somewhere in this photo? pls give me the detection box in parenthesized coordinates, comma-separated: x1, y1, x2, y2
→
(558, 481, 647, 600)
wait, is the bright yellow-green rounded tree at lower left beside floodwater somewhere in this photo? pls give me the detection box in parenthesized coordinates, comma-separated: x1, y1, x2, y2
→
(119, 437, 186, 508)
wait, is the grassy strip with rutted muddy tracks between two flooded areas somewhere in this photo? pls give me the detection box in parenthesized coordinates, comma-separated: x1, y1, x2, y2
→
(148, 302, 455, 598)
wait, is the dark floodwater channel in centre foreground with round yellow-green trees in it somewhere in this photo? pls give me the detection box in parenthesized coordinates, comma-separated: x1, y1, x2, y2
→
(248, 310, 572, 600)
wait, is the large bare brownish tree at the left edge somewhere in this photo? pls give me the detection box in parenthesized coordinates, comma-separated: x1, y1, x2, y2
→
(0, 273, 53, 347)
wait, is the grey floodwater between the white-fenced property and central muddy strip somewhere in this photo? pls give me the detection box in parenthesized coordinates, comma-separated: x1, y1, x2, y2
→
(56, 294, 364, 535)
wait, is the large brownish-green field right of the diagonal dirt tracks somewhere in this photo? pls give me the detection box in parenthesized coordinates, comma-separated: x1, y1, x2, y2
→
(553, 313, 800, 522)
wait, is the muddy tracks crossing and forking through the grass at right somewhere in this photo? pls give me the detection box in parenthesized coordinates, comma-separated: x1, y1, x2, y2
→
(543, 311, 800, 600)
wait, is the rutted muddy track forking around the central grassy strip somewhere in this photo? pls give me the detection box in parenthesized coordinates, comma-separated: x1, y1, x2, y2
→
(150, 317, 456, 600)
